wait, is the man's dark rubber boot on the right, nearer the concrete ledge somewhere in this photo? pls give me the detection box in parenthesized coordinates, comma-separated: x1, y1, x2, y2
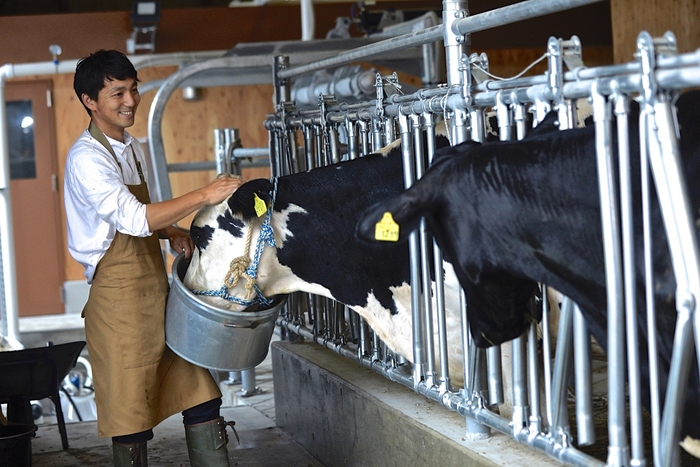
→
(185, 417, 238, 467)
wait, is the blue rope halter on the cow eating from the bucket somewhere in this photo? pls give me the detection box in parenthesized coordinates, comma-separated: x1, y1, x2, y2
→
(192, 177, 277, 307)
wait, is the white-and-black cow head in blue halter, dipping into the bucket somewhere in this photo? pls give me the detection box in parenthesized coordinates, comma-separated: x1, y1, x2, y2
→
(183, 179, 284, 311)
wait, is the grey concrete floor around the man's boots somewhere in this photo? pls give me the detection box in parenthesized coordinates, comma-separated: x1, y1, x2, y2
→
(19, 337, 323, 467)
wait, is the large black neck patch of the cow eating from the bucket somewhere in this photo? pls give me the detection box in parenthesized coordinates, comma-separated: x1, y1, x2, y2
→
(266, 137, 448, 314)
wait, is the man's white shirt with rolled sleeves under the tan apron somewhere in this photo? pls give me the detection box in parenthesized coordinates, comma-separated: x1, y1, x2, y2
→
(63, 126, 152, 284)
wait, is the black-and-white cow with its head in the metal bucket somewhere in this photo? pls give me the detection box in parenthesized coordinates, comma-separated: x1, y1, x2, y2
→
(183, 141, 462, 382)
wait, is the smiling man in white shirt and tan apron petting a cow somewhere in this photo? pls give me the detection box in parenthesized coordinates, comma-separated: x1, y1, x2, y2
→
(64, 50, 241, 467)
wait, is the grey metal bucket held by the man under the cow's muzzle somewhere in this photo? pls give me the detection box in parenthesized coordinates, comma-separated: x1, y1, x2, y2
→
(165, 254, 287, 371)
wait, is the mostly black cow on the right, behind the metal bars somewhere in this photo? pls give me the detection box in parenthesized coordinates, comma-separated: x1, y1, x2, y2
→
(357, 92, 700, 450)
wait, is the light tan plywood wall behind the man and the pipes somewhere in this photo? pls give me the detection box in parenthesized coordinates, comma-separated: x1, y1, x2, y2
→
(29, 67, 272, 280)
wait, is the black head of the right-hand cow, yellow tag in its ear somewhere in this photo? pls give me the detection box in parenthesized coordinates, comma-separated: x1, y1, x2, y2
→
(356, 138, 542, 347)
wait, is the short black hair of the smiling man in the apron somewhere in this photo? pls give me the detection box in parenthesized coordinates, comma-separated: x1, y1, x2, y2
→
(73, 49, 138, 115)
